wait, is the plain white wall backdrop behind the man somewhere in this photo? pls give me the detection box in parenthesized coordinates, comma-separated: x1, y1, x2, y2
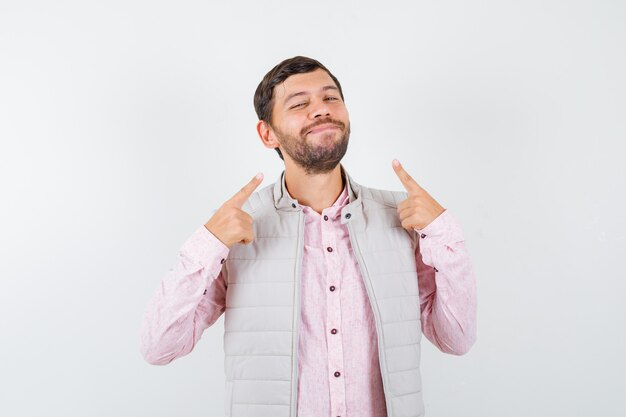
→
(0, 0, 626, 417)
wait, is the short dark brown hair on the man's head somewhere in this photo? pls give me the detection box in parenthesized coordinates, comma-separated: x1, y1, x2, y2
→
(254, 56, 345, 160)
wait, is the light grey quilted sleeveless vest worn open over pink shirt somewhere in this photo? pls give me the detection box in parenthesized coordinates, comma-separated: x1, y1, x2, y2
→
(222, 166, 424, 417)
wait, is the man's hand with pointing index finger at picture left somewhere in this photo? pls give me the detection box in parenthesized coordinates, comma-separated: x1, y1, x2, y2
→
(204, 173, 263, 249)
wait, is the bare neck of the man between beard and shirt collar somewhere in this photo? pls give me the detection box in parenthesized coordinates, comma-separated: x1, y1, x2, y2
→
(285, 161, 345, 214)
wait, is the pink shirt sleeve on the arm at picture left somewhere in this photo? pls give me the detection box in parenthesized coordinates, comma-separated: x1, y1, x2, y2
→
(140, 225, 229, 365)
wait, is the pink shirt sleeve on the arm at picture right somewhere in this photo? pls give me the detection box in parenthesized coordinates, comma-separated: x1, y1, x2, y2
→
(415, 210, 477, 355)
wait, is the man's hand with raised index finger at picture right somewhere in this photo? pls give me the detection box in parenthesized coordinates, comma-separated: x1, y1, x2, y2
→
(392, 159, 446, 232)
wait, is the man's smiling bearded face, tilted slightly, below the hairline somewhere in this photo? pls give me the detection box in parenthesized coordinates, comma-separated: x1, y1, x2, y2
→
(269, 69, 350, 174)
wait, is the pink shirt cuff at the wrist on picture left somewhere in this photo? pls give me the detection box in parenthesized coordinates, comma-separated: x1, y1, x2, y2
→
(180, 225, 230, 272)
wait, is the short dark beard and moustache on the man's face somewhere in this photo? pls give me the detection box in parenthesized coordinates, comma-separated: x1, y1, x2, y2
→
(274, 119, 350, 175)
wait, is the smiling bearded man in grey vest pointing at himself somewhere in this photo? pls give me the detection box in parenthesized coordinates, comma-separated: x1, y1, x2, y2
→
(141, 56, 476, 417)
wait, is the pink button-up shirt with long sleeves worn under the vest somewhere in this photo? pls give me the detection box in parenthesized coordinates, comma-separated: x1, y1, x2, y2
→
(140, 187, 476, 417)
